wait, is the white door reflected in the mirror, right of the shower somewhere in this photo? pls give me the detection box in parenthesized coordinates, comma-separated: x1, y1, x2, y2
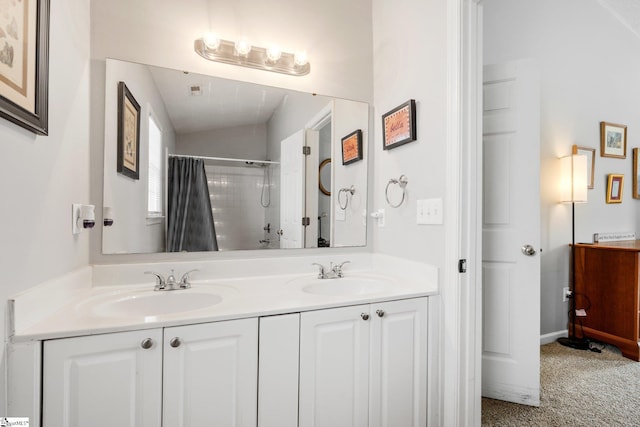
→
(280, 130, 304, 248)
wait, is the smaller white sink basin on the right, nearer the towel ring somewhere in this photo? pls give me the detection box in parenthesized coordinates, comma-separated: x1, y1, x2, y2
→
(296, 276, 395, 296)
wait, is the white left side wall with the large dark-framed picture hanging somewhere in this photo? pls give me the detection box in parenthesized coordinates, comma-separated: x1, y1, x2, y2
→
(0, 0, 91, 408)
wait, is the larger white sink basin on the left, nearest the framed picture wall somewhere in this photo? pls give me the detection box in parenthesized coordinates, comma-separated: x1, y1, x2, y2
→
(80, 288, 231, 321)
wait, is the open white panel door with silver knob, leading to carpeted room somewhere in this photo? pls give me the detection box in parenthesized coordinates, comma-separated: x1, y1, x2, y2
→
(482, 61, 540, 406)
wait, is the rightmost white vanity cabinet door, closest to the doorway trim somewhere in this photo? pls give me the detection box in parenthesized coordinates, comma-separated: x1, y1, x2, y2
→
(369, 298, 428, 427)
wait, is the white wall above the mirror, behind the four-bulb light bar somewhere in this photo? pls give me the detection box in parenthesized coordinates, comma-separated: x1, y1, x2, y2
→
(91, 0, 372, 102)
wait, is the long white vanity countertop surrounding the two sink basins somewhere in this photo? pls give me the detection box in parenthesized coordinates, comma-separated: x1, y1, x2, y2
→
(10, 259, 438, 342)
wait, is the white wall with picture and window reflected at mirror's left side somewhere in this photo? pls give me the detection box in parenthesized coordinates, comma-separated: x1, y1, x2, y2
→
(104, 61, 176, 253)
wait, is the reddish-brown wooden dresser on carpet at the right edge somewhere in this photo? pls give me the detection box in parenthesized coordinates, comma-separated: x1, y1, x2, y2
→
(570, 240, 640, 361)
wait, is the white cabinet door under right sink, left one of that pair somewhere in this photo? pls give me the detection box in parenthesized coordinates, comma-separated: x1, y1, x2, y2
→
(300, 305, 370, 427)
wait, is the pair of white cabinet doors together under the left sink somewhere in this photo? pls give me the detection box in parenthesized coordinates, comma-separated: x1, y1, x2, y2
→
(42, 318, 258, 427)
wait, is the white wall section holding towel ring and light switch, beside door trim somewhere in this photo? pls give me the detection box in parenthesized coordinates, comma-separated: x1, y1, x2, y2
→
(370, 0, 444, 268)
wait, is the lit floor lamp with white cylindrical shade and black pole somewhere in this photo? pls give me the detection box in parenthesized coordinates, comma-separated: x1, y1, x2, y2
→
(558, 154, 589, 350)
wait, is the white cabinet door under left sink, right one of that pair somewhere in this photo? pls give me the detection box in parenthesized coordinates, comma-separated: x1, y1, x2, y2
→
(163, 318, 258, 427)
